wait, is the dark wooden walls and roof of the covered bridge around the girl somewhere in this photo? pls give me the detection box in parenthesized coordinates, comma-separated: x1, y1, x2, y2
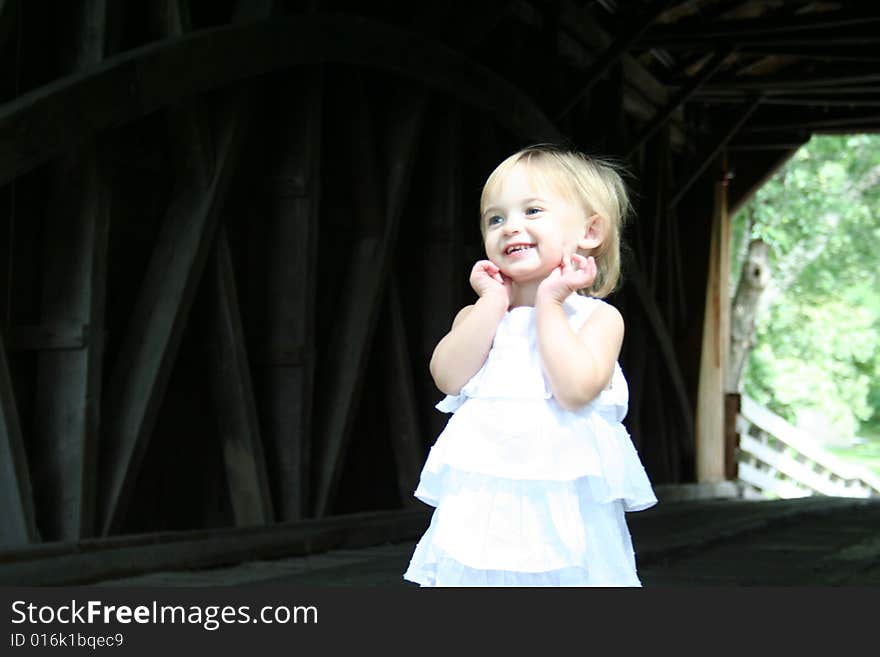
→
(0, 0, 880, 582)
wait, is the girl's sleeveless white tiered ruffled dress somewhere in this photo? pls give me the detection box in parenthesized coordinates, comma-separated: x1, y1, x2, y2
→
(404, 295, 657, 586)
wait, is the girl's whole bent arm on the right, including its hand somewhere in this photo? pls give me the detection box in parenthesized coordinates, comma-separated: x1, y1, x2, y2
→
(535, 254, 623, 410)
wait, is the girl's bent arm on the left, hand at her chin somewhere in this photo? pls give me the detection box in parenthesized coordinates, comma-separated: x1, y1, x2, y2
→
(430, 261, 510, 395)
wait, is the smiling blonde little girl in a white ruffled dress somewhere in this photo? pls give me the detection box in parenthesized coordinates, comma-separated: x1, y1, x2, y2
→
(404, 146, 657, 586)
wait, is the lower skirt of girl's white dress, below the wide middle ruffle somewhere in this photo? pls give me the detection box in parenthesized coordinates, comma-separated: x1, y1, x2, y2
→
(404, 469, 640, 586)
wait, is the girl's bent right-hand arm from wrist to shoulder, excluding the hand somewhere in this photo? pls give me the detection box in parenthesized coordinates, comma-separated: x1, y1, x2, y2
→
(535, 301, 624, 410)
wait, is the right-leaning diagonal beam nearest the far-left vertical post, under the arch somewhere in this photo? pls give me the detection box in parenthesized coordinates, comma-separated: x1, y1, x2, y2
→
(100, 98, 249, 534)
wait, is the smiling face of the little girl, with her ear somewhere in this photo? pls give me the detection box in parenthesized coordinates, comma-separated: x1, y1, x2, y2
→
(481, 163, 598, 283)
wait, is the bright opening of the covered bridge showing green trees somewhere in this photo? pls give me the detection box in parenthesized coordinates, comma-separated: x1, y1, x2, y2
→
(725, 134, 880, 497)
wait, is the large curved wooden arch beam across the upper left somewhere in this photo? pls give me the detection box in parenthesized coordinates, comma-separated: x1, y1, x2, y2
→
(0, 14, 561, 184)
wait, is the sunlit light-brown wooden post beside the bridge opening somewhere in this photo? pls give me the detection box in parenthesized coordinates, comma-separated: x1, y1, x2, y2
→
(696, 160, 730, 482)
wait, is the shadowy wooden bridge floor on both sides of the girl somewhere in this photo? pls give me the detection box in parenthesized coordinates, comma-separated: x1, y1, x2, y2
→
(89, 497, 880, 587)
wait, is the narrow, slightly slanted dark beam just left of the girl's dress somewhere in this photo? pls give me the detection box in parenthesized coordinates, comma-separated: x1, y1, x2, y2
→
(385, 276, 426, 507)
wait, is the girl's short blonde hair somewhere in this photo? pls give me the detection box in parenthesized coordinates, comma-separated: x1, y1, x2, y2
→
(480, 144, 630, 298)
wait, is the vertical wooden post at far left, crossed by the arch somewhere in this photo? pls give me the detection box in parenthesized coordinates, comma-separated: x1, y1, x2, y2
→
(30, 0, 109, 540)
